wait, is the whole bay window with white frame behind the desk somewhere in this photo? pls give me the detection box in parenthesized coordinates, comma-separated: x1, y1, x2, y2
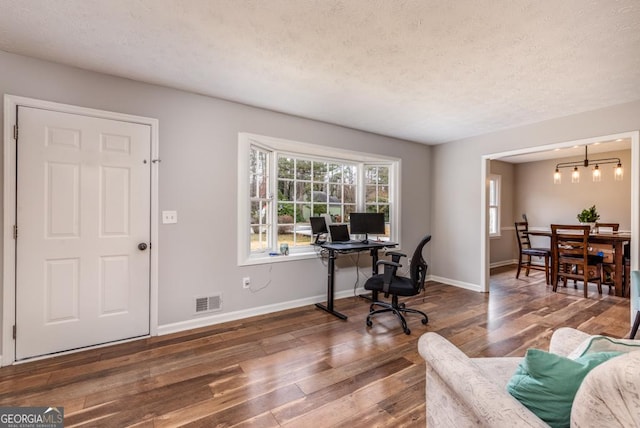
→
(238, 133, 400, 265)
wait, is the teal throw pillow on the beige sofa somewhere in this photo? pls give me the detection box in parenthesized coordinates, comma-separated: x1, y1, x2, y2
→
(507, 349, 621, 427)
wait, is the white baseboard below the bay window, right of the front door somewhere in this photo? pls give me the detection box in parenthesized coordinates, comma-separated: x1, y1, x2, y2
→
(158, 288, 367, 336)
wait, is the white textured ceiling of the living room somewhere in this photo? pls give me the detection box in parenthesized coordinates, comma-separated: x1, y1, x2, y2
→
(0, 0, 640, 144)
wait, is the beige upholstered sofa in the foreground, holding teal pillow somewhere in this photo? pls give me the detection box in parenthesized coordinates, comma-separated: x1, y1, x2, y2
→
(418, 328, 640, 428)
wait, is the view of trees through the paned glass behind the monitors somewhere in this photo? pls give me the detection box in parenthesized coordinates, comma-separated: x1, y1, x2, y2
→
(249, 146, 391, 252)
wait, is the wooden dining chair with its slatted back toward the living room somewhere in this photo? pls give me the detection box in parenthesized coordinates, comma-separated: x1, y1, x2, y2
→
(551, 224, 602, 297)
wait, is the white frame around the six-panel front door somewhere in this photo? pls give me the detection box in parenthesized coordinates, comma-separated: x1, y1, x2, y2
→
(0, 94, 159, 366)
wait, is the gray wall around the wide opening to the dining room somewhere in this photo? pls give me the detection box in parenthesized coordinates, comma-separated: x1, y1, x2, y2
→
(431, 101, 640, 286)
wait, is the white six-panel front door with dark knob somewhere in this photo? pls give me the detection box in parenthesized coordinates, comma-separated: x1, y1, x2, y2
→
(16, 106, 151, 360)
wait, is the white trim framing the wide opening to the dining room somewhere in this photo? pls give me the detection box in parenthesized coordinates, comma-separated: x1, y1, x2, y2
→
(480, 131, 640, 293)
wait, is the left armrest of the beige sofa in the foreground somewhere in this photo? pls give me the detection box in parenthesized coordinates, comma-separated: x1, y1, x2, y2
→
(418, 333, 548, 427)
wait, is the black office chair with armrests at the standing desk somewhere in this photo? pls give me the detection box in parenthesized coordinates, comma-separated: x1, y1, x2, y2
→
(364, 235, 431, 334)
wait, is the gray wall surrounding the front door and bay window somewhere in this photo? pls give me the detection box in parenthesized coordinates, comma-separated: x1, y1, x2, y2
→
(0, 51, 431, 334)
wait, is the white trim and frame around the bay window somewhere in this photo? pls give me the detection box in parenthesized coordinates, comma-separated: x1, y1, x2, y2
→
(236, 132, 401, 266)
